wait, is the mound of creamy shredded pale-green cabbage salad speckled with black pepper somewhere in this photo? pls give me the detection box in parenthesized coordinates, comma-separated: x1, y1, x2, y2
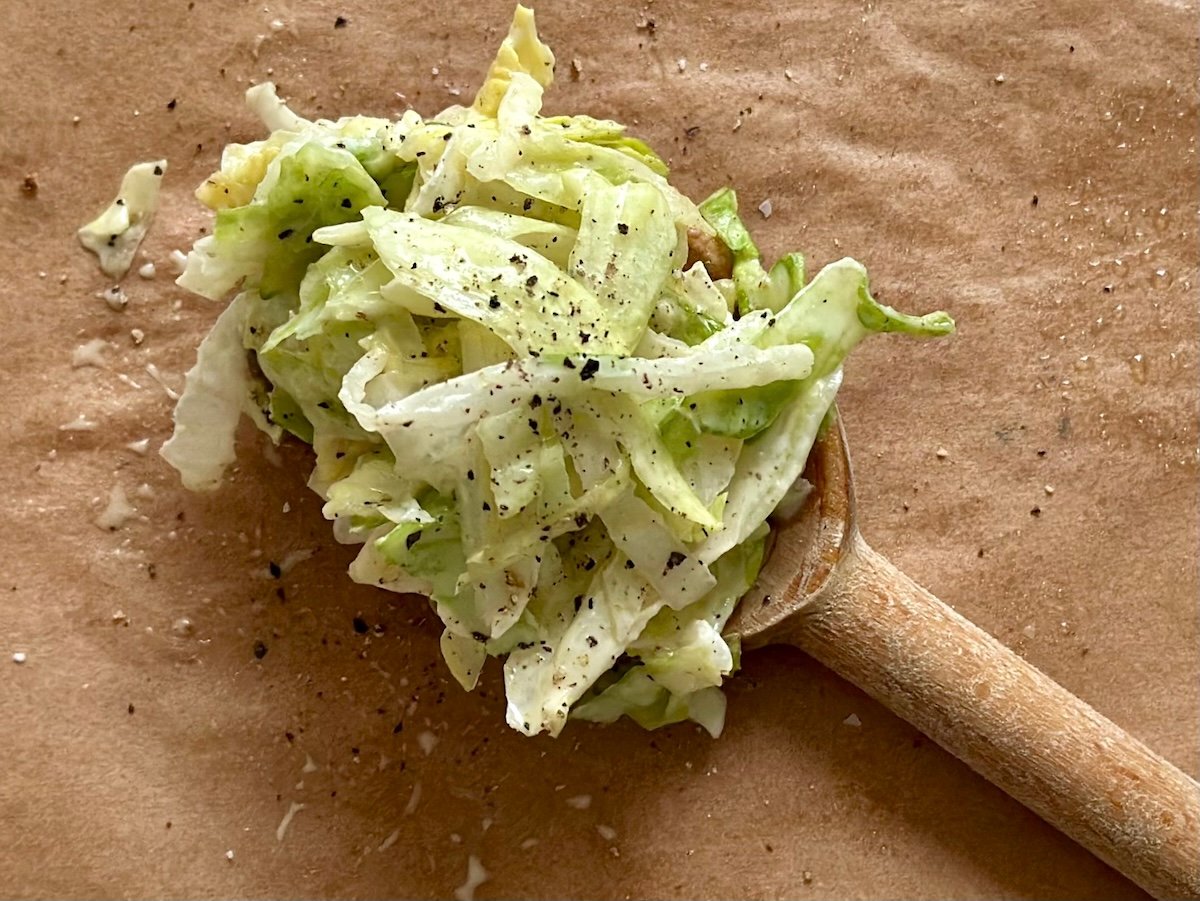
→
(162, 7, 953, 737)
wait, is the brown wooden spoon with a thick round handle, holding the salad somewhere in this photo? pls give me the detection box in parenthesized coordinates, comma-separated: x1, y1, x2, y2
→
(727, 419, 1200, 899)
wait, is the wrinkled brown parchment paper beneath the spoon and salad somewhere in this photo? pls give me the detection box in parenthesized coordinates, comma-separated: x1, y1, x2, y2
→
(0, 0, 1200, 899)
